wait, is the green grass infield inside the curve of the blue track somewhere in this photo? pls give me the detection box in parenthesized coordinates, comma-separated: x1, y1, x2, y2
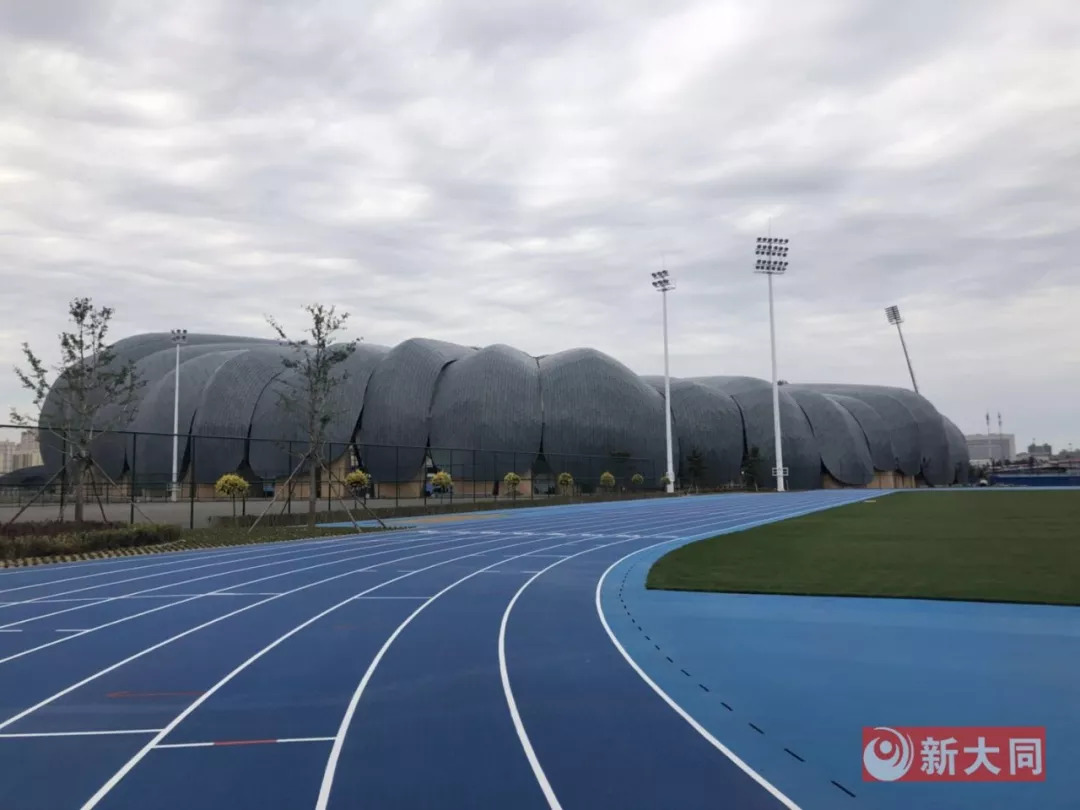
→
(646, 490, 1080, 605)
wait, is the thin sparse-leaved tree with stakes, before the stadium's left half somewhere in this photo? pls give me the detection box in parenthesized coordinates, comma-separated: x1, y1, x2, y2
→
(267, 303, 359, 527)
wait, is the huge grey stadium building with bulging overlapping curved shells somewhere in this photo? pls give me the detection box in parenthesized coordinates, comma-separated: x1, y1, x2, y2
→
(23, 334, 968, 497)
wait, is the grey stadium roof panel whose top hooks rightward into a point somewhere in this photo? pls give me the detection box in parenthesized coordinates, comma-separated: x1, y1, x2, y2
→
(357, 338, 474, 482)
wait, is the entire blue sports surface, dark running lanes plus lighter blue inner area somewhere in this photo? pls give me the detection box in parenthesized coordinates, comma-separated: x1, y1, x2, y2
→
(0, 491, 1076, 810)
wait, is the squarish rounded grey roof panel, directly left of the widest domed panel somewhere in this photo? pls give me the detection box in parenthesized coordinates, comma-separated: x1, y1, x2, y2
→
(431, 345, 543, 481)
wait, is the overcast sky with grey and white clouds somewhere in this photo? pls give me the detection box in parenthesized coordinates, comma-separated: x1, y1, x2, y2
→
(0, 0, 1080, 447)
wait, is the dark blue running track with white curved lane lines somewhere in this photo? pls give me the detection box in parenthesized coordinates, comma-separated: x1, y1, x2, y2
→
(0, 491, 881, 810)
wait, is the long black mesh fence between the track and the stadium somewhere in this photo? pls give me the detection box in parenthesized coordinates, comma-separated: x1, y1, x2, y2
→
(0, 426, 663, 526)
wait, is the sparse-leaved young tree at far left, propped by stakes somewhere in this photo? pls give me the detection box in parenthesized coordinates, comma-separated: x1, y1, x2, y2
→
(11, 298, 144, 523)
